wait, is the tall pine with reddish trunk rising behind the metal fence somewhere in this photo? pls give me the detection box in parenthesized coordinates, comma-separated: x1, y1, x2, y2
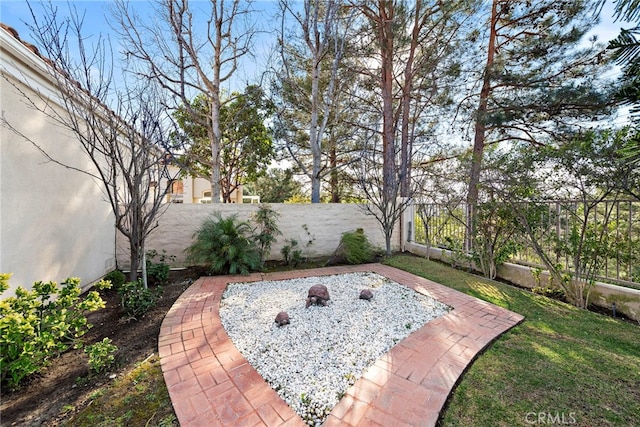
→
(467, 0, 610, 244)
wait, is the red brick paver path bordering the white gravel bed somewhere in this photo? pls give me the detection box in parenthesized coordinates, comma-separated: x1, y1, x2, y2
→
(158, 264, 524, 427)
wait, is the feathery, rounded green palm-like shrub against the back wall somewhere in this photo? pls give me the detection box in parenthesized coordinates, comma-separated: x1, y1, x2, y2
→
(187, 212, 260, 274)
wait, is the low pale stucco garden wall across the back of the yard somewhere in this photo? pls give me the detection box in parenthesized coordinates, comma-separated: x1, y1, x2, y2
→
(117, 203, 399, 269)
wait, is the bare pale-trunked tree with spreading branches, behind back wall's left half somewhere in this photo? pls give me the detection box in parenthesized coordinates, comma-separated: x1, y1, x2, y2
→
(114, 0, 256, 203)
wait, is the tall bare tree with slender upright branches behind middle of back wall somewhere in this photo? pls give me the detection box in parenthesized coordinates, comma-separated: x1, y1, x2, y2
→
(274, 0, 353, 203)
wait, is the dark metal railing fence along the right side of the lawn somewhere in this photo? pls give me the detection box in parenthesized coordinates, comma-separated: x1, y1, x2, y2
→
(413, 200, 640, 287)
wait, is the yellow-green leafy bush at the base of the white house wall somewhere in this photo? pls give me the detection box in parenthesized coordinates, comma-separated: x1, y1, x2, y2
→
(0, 274, 106, 388)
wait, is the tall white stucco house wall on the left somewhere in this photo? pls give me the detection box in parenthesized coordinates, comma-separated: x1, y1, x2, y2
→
(0, 25, 115, 297)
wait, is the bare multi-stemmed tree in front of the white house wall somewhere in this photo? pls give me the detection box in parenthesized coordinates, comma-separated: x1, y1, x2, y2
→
(2, 4, 180, 285)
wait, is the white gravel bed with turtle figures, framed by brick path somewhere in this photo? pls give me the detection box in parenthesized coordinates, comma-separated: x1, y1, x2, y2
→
(220, 273, 449, 425)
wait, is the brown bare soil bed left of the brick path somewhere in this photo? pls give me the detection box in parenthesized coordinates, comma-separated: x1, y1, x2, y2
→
(0, 268, 203, 426)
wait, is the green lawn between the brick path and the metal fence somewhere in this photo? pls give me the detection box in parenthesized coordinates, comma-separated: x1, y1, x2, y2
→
(385, 255, 640, 426)
